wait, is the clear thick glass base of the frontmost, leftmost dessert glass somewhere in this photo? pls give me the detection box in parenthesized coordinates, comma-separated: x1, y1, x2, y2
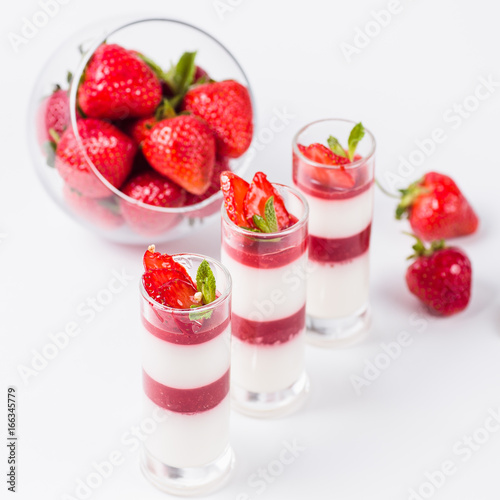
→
(141, 446, 234, 497)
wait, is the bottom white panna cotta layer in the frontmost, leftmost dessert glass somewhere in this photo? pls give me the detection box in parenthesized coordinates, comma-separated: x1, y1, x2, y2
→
(143, 394, 230, 467)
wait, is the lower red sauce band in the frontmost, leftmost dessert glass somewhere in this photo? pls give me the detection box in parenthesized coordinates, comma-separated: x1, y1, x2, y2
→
(142, 370, 229, 414)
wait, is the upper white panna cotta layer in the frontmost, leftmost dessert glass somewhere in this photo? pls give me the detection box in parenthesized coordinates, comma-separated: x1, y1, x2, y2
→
(142, 327, 231, 389)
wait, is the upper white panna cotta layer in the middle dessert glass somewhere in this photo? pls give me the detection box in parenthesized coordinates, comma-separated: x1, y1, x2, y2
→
(221, 247, 307, 321)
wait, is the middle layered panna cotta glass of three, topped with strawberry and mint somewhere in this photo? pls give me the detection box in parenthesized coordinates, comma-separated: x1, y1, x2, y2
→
(221, 172, 308, 416)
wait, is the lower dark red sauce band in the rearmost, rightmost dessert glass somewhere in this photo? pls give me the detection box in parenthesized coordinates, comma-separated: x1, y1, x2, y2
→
(309, 224, 372, 263)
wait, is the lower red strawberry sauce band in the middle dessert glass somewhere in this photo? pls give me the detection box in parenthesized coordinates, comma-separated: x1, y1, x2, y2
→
(232, 305, 306, 345)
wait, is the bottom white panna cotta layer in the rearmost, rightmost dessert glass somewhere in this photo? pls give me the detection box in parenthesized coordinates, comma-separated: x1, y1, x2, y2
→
(306, 252, 370, 318)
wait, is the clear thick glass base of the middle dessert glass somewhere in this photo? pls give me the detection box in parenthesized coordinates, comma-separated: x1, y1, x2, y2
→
(231, 372, 309, 418)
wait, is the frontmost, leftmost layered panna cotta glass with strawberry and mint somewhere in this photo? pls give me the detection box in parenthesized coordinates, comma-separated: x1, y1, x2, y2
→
(141, 245, 233, 495)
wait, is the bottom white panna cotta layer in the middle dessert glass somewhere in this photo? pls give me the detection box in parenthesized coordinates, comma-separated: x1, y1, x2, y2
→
(231, 329, 305, 392)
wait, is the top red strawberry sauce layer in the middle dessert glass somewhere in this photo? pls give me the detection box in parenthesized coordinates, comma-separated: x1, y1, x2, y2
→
(222, 222, 307, 269)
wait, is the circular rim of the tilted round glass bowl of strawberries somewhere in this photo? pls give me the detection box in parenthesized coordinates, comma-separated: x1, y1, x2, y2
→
(69, 16, 255, 215)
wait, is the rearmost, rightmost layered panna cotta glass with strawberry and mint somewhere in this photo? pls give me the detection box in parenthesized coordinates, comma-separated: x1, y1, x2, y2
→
(293, 119, 375, 347)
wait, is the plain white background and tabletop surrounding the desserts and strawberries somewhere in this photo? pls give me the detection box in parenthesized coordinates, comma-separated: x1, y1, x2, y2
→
(0, 0, 500, 500)
